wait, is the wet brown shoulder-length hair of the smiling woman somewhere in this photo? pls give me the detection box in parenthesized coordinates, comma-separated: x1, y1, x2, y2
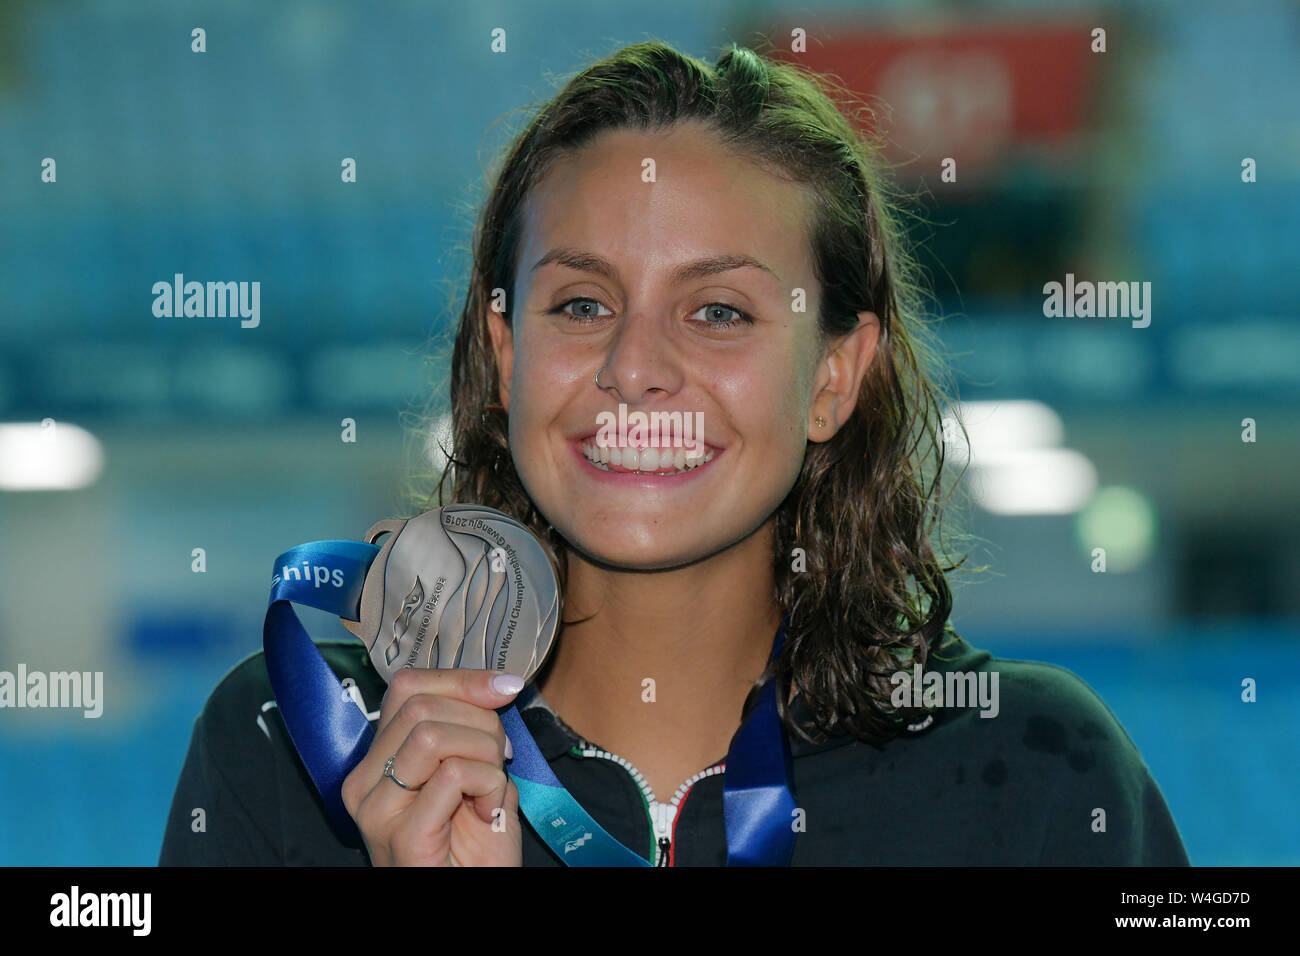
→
(410, 42, 958, 744)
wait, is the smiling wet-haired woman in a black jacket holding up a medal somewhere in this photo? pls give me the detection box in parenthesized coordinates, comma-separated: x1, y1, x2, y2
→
(163, 42, 1187, 865)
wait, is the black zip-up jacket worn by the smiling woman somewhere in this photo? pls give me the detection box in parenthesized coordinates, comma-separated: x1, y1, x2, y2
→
(159, 639, 1188, 866)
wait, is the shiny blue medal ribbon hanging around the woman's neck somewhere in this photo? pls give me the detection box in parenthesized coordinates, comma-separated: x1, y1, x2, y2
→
(263, 541, 796, 866)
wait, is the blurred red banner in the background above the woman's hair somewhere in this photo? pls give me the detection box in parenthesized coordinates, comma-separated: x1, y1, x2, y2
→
(775, 21, 1110, 174)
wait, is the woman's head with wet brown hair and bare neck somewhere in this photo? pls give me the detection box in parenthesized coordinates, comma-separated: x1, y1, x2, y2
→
(441, 43, 952, 792)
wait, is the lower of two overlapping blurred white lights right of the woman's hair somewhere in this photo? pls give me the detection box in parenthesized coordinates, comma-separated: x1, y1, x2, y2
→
(967, 449, 1097, 515)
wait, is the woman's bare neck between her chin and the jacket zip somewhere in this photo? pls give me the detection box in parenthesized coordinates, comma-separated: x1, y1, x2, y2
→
(538, 524, 781, 800)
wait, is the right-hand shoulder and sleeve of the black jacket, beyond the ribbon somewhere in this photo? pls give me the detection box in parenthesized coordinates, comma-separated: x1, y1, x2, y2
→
(780, 636, 1187, 866)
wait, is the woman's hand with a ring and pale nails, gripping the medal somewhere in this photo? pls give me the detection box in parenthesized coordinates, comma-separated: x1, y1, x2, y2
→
(343, 667, 524, 866)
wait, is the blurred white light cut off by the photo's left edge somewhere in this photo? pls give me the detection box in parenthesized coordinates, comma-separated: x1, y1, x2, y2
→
(0, 419, 104, 492)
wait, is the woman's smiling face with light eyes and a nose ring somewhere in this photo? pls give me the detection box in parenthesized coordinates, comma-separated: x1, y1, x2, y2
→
(489, 124, 852, 570)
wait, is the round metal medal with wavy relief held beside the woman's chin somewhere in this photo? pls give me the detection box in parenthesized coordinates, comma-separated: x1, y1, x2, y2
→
(343, 505, 560, 680)
